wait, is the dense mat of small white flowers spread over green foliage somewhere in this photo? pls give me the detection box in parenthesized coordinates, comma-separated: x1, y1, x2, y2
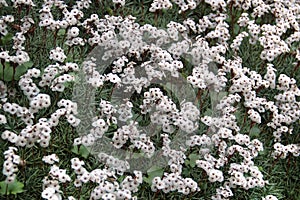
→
(0, 0, 300, 200)
